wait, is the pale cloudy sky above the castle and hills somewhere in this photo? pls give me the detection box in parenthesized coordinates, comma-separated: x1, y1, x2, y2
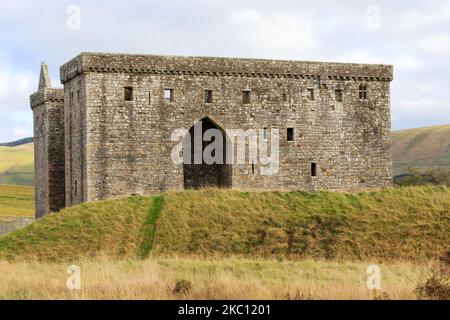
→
(0, 0, 450, 142)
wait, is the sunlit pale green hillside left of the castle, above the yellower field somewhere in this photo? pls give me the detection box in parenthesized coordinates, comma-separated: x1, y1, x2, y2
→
(0, 143, 34, 186)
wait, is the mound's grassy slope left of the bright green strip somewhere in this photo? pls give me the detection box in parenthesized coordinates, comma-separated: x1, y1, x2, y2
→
(0, 197, 160, 260)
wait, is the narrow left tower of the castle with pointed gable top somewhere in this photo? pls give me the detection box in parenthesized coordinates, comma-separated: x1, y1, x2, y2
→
(30, 63, 65, 218)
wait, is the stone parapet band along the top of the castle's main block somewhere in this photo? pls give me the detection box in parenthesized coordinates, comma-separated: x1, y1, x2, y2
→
(60, 53, 393, 83)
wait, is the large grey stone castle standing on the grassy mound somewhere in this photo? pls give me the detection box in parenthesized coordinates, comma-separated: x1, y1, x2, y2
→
(30, 53, 393, 217)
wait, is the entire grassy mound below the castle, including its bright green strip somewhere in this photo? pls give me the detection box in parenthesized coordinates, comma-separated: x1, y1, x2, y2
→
(0, 187, 450, 261)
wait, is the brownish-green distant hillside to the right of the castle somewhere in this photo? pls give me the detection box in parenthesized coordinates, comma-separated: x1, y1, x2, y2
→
(392, 125, 450, 175)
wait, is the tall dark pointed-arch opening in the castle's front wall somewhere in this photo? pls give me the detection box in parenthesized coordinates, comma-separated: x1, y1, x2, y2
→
(183, 118, 232, 189)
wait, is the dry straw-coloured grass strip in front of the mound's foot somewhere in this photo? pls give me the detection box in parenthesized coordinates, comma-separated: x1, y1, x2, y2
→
(0, 257, 429, 299)
